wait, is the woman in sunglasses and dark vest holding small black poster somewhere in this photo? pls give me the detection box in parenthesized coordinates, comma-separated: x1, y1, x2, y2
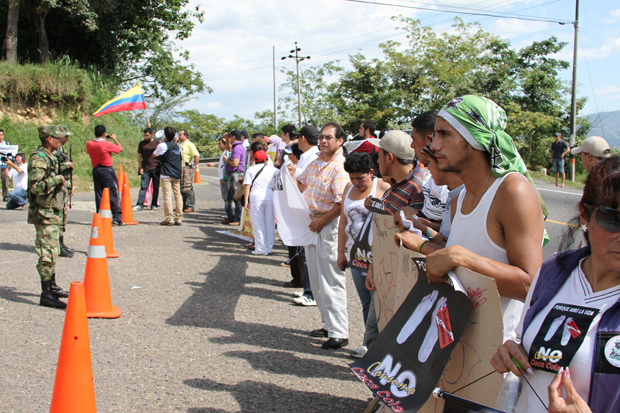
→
(491, 156, 620, 412)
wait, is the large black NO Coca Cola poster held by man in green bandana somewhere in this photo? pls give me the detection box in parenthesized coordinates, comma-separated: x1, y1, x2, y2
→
(350, 258, 472, 412)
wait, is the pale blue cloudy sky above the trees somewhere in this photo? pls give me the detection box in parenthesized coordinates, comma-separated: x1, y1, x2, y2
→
(174, 0, 620, 125)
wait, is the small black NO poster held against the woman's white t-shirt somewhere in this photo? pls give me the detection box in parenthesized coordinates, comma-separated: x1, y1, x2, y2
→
(529, 303, 599, 373)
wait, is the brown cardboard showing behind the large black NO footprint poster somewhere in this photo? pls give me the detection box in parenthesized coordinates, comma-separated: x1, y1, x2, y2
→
(372, 213, 503, 413)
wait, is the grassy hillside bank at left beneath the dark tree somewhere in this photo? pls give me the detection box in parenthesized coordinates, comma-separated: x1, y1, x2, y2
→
(0, 58, 150, 191)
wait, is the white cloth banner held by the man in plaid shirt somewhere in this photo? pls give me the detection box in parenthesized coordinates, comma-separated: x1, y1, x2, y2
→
(273, 160, 318, 247)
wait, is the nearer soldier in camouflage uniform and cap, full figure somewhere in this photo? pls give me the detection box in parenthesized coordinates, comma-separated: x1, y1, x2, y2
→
(28, 125, 69, 308)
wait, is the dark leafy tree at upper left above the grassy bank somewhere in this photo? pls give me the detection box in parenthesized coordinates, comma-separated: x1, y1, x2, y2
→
(0, 0, 211, 99)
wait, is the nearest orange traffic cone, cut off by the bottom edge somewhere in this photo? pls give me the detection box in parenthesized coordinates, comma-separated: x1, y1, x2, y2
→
(50, 282, 97, 413)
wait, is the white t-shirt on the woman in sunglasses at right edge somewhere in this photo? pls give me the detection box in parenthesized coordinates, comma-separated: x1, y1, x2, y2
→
(516, 260, 620, 412)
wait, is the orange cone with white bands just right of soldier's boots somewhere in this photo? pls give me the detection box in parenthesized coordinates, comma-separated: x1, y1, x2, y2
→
(84, 214, 121, 318)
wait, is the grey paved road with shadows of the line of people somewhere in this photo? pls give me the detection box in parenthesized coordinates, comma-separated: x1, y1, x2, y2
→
(0, 168, 578, 413)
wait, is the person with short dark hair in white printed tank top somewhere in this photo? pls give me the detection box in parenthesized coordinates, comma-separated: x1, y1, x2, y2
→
(338, 152, 389, 358)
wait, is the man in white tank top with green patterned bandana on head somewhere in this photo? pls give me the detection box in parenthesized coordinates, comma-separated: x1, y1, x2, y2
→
(426, 95, 544, 340)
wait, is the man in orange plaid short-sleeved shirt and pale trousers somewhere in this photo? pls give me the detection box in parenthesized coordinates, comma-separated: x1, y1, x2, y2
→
(289, 122, 349, 349)
